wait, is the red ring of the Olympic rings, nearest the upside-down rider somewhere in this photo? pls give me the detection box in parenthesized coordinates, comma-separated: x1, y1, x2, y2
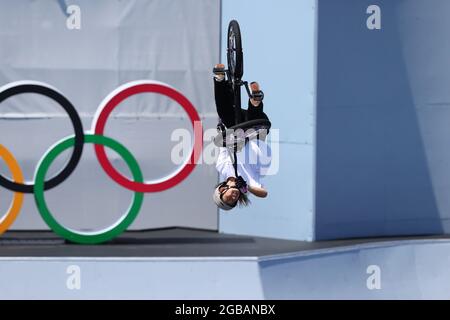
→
(92, 80, 203, 192)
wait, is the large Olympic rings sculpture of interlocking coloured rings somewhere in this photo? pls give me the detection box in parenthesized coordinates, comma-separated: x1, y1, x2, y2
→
(0, 80, 203, 244)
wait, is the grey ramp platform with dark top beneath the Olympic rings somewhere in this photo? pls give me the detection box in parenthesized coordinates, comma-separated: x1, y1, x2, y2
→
(0, 228, 450, 299)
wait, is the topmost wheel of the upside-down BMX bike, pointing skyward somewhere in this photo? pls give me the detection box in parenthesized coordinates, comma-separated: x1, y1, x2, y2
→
(227, 20, 244, 82)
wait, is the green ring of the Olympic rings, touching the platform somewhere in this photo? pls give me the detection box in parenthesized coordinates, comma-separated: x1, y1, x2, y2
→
(34, 134, 144, 244)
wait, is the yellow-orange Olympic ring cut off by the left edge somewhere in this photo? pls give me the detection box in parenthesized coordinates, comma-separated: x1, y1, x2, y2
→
(0, 144, 24, 234)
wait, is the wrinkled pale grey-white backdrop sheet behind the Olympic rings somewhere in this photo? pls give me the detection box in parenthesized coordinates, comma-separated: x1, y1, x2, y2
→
(0, 0, 220, 230)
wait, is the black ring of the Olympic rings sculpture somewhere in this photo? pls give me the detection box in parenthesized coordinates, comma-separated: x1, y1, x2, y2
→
(0, 81, 84, 193)
